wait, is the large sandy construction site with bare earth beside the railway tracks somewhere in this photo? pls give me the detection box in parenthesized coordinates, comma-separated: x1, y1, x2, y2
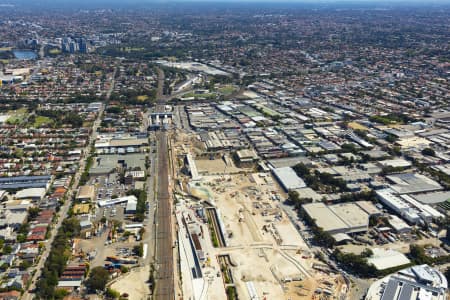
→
(174, 131, 348, 299)
